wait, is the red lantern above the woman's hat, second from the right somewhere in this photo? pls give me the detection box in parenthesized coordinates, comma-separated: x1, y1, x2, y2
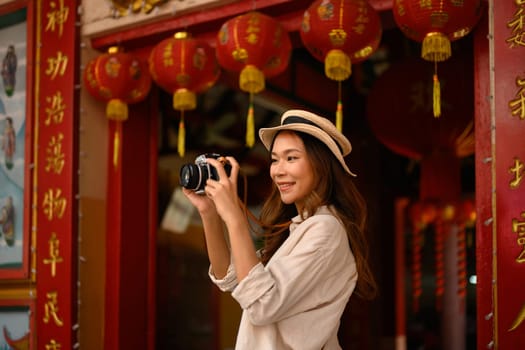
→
(300, 0, 383, 130)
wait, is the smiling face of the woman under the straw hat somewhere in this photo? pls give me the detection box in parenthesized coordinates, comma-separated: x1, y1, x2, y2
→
(270, 131, 316, 213)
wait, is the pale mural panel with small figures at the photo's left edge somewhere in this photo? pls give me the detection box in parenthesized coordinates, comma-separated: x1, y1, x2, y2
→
(0, 4, 29, 278)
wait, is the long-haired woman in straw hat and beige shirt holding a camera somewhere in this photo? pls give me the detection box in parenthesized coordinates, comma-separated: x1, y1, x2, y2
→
(183, 110, 376, 350)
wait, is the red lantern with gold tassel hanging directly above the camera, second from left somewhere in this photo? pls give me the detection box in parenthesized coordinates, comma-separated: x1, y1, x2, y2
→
(149, 32, 220, 157)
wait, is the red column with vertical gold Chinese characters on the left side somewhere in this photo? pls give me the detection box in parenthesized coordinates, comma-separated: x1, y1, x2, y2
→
(35, 0, 79, 349)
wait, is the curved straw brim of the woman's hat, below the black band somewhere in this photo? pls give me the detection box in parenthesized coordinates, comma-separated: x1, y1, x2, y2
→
(259, 123, 357, 176)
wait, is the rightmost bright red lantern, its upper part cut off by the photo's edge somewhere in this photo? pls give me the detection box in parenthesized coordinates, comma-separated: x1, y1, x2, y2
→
(392, 0, 482, 117)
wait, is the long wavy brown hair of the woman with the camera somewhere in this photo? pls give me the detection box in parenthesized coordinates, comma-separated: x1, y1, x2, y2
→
(259, 131, 377, 299)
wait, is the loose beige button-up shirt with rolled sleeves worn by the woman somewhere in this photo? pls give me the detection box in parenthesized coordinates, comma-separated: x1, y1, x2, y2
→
(210, 207, 357, 350)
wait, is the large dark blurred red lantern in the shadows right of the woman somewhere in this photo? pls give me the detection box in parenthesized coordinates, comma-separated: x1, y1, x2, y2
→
(367, 55, 475, 200)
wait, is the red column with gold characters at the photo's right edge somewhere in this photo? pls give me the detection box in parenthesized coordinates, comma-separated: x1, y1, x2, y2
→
(475, 0, 525, 350)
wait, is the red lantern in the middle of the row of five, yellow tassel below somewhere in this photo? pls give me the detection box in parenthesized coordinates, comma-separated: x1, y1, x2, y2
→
(216, 11, 292, 147)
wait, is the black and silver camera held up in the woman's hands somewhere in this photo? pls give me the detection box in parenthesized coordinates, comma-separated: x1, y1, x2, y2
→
(180, 153, 231, 194)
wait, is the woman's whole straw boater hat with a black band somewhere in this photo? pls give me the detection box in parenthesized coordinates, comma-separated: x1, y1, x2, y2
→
(259, 109, 356, 176)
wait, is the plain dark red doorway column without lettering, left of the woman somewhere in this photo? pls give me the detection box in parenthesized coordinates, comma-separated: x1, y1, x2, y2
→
(104, 88, 157, 350)
